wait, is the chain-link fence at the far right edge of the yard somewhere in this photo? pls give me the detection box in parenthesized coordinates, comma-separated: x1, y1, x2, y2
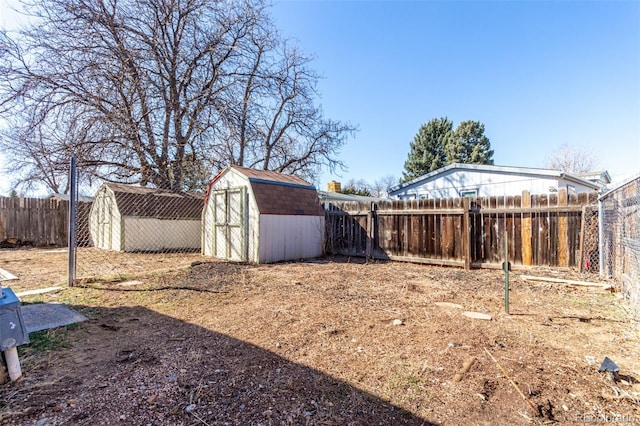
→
(600, 176, 640, 317)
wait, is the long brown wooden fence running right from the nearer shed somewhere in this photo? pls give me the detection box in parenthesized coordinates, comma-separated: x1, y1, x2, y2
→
(325, 189, 597, 269)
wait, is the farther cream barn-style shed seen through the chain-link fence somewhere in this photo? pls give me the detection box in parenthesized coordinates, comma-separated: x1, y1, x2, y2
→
(89, 183, 204, 252)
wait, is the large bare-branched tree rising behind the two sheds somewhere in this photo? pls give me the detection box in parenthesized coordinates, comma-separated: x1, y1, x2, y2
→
(0, 0, 355, 192)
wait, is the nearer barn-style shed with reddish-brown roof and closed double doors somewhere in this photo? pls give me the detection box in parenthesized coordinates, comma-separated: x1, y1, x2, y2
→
(202, 166, 324, 263)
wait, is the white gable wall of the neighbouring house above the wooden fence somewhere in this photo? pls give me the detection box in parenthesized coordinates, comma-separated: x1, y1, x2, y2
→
(393, 170, 592, 200)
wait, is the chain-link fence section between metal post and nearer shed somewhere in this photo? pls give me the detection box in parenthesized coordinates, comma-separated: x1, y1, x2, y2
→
(69, 161, 204, 285)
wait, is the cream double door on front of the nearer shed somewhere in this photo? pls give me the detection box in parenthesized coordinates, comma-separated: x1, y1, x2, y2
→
(213, 187, 247, 261)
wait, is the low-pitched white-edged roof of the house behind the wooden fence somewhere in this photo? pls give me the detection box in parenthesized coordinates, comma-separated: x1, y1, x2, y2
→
(388, 163, 602, 194)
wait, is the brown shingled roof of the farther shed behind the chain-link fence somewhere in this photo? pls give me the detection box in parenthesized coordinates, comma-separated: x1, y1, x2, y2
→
(103, 183, 204, 219)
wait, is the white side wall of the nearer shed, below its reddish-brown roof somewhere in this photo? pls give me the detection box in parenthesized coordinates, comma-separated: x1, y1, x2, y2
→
(259, 215, 324, 263)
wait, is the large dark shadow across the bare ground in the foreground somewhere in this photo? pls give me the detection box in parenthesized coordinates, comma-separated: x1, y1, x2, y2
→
(0, 306, 434, 425)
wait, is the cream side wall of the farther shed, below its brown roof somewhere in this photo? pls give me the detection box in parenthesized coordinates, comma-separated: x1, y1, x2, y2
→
(124, 216, 200, 251)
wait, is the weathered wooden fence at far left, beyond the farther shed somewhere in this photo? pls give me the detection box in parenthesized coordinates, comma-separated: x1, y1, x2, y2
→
(0, 197, 91, 246)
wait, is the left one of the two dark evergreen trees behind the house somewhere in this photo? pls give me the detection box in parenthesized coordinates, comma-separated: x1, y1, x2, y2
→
(402, 117, 453, 182)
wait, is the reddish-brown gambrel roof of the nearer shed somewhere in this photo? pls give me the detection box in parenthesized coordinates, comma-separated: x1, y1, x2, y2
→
(209, 166, 324, 216)
